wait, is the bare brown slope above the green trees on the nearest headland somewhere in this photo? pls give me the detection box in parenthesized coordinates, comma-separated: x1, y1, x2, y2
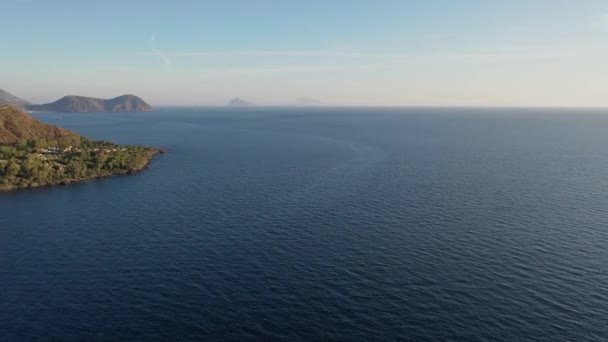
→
(0, 105, 81, 144)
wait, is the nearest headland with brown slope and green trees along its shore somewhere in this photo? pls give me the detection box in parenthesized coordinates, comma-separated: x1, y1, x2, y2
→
(0, 105, 164, 191)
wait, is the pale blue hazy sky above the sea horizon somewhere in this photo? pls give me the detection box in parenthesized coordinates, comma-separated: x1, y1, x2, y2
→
(0, 0, 608, 107)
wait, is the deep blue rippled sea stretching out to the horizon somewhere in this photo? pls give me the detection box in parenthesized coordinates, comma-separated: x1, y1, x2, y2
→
(0, 108, 608, 341)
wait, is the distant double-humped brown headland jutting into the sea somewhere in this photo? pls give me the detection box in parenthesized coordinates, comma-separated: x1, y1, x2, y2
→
(27, 95, 152, 113)
